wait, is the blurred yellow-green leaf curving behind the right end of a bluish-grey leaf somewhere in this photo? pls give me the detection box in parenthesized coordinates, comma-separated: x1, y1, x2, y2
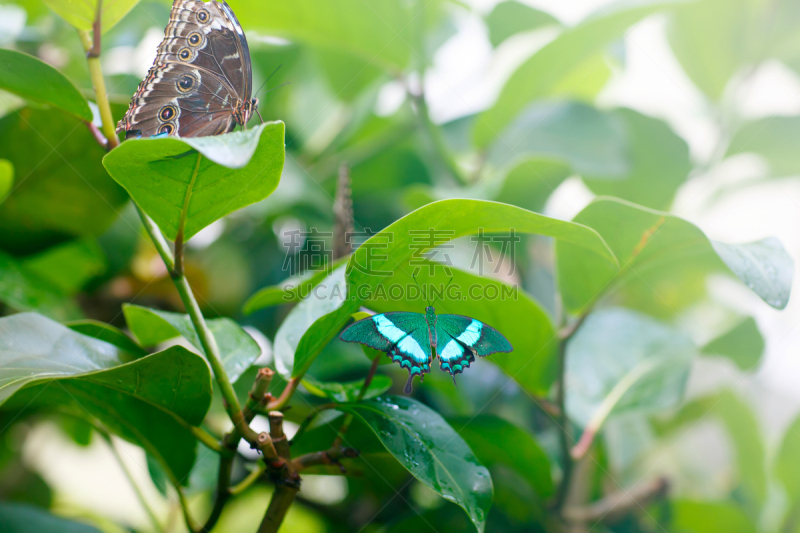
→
(576, 109, 692, 209)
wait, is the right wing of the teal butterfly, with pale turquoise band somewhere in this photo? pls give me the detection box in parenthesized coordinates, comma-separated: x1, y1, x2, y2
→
(436, 315, 513, 381)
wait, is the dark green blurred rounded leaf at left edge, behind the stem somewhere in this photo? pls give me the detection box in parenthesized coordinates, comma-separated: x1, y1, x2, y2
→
(0, 108, 128, 253)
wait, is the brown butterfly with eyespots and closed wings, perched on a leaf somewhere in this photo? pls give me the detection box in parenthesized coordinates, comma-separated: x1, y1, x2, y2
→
(117, 0, 261, 139)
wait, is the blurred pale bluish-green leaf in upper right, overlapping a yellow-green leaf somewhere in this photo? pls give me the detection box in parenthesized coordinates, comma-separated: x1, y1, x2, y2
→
(489, 102, 629, 179)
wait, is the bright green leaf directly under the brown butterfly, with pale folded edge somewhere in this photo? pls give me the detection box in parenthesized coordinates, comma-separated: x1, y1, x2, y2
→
(103, 122, 284, 241)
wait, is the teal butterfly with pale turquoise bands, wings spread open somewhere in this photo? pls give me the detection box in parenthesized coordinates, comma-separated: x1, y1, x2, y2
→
(340, 306, 512, 394)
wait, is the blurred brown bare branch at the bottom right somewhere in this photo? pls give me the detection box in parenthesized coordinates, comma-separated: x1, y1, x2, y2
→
(562, 477, 669, 524)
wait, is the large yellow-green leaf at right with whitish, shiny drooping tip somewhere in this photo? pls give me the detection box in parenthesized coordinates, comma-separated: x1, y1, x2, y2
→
(556, 198, 792, 314)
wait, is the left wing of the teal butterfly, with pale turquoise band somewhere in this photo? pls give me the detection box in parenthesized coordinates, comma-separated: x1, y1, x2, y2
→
(339, 312, 432, 394)
